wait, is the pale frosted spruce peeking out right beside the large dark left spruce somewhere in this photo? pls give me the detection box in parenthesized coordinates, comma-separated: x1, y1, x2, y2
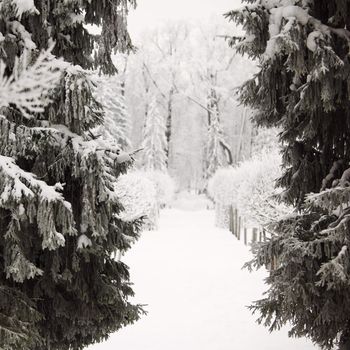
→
(96, 75, 130, 150)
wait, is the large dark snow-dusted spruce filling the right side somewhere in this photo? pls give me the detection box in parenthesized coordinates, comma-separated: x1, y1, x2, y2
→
(227, 0, 350, 349)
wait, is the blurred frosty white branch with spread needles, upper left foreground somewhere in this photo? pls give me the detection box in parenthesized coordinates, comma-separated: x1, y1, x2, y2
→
(0, 46, 67, 118)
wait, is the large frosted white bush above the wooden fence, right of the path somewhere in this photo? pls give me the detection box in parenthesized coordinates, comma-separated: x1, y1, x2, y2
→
(208, 151, 291, 227)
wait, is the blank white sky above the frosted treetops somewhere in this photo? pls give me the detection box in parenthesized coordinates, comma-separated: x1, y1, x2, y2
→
(128, 0, 241, 36)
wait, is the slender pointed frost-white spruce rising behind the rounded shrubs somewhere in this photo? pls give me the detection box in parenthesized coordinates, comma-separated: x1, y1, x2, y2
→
(142, 100, 167, 171)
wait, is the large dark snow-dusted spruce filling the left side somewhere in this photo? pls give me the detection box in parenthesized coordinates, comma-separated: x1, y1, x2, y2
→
(0, 0, 142, 350)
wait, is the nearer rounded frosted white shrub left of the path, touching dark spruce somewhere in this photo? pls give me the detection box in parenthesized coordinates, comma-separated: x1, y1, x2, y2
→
(115, 171, 159, 229)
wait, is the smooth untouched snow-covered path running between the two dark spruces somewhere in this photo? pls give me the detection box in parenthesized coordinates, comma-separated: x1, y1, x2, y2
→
(89, 209, 316, 350)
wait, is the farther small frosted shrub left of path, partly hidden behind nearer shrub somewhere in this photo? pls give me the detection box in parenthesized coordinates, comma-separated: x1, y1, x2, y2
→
(145, 170, 175, 208)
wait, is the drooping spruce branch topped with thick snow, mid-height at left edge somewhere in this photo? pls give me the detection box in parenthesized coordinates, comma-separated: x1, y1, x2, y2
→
(0, 156, 76, 250)
